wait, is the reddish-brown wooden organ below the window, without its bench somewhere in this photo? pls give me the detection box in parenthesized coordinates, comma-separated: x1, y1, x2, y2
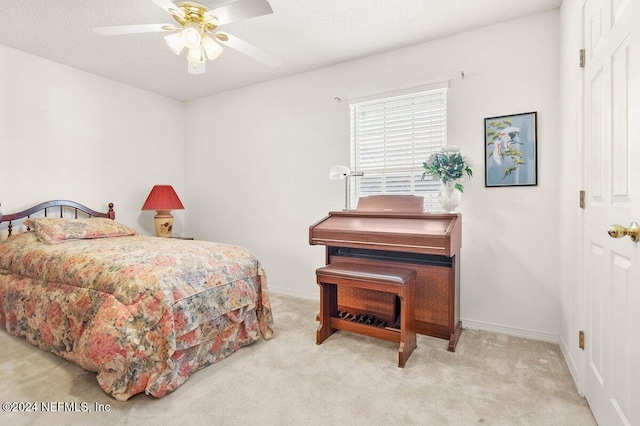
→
(309, 195, 462, 352)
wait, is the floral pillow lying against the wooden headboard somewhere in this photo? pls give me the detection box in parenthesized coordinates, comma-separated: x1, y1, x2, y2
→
(24, 217, 136, 244)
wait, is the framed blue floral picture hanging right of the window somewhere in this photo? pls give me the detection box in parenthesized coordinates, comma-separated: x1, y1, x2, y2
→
(484, 111, 538, 187)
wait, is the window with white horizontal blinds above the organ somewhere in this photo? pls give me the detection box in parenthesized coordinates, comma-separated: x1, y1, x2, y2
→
(349, 83, 447, 210)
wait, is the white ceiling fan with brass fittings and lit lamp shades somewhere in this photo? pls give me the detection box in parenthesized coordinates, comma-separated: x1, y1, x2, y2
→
(93, 0, 281, 74)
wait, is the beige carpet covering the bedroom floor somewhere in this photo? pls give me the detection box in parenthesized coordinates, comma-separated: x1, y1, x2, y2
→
(0, 294, 595, 426)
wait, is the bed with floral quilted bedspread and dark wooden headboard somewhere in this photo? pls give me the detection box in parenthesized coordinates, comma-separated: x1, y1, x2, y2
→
(0, 200, 273, 401)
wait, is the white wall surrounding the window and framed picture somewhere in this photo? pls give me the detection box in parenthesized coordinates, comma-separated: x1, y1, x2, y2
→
(185, 10, 563, 340)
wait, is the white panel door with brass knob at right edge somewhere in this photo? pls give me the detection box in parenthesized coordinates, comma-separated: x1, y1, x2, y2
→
(582, 0, 640, 426)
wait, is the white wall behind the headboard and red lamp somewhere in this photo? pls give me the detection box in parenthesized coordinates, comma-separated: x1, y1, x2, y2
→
(0, 45, 184, 234)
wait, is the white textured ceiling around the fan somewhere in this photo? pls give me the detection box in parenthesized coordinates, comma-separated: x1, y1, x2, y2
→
(0, 0, 562, 101)
